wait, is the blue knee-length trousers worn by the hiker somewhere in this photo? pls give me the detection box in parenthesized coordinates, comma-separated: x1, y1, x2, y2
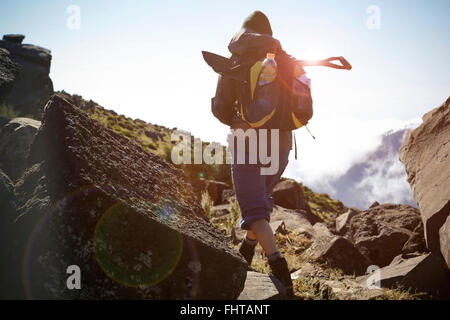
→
(231, 149, 290, 230)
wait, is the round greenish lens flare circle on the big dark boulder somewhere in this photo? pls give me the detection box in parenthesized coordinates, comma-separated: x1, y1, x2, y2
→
(94, 202, 183, 287)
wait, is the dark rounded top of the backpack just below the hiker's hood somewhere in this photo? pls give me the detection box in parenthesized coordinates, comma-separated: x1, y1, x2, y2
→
(228, 28, 282, 56)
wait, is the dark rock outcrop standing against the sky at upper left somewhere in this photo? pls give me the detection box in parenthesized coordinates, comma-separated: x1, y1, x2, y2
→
(0, 35, 53, 119)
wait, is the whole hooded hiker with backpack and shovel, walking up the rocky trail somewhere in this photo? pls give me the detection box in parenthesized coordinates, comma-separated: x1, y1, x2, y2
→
(207, 11, 352, 297)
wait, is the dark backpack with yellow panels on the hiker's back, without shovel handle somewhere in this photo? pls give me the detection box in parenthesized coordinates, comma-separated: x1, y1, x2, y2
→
(204, 53, 313, 130)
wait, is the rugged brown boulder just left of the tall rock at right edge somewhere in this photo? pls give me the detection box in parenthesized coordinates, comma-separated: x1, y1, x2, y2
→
(345, 204, 423, 267)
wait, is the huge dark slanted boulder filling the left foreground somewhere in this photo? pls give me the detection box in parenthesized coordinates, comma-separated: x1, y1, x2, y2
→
(7, 95, 246, 299)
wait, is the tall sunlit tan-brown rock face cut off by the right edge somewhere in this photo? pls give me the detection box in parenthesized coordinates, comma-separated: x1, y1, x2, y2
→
(400, 98, 450, 267)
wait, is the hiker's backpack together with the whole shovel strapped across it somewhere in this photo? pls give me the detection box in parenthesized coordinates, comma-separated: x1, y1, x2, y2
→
(202, 51, 352, 131)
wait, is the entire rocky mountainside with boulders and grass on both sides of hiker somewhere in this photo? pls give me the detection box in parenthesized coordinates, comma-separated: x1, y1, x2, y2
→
(0, 35, 450, 300)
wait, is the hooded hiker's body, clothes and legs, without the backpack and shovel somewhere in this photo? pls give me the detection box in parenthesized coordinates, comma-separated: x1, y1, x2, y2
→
(212, 11, 293, 296)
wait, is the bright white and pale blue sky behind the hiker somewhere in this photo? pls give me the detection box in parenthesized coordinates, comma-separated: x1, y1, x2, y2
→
(0, 0, 450, 188)
